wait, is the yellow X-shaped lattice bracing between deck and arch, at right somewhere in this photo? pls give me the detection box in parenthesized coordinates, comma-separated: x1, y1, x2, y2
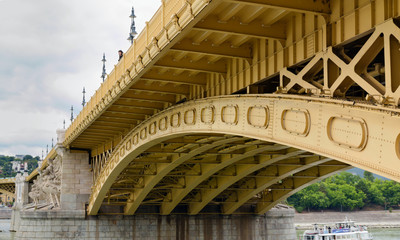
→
(278, 19, 400, 106)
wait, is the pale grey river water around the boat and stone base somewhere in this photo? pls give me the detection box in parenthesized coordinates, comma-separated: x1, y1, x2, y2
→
(0, 219, 400, 240)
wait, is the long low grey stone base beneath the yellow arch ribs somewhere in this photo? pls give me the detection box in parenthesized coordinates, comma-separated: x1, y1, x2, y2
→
(16, 209, 295, 240)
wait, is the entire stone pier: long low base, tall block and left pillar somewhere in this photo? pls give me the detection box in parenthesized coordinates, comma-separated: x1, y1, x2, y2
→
(13, 130, 295, 240)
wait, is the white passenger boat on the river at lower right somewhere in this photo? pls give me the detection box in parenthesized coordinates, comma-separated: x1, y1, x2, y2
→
(300, 218, 373, 240)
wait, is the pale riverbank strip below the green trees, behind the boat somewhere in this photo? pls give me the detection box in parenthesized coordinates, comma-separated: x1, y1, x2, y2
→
(294, 210, 400, 229)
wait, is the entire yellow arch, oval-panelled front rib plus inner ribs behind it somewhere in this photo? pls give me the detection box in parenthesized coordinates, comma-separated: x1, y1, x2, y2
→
(88, 94, 400, 215)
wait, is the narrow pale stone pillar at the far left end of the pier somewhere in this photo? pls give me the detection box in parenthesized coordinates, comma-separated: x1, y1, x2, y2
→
(10, 172, 29, 231)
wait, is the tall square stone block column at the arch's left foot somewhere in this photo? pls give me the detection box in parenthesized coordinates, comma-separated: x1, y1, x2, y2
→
(56, 129, 93, 211)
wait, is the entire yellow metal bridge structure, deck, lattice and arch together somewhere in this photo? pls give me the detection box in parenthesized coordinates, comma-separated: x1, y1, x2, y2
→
(14, 0, 400, 215)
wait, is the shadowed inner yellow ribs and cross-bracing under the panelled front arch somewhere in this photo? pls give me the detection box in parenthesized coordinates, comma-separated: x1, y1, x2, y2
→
(95, 134, 348, 214)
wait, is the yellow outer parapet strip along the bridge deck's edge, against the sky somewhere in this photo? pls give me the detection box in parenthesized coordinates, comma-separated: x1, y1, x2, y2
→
(64, 0, 203, 145)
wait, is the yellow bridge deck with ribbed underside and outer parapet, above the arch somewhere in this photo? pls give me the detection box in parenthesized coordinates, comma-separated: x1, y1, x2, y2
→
(64, 0, 399, 152)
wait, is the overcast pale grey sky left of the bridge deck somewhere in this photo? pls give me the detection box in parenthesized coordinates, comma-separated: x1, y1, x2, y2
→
(0, 0, 161, 156)
